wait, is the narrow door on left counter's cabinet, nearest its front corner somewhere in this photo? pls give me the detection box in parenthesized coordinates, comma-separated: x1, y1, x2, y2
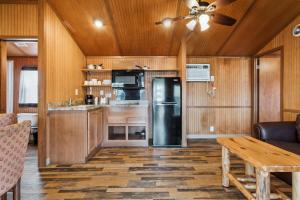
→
(88, 111, 98, 153)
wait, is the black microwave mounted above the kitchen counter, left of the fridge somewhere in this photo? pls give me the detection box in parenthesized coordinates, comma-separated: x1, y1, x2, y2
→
(112, 70, 145, 89)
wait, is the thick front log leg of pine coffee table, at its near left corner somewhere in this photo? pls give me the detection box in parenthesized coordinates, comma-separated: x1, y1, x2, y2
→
(256, 169, 270, 200)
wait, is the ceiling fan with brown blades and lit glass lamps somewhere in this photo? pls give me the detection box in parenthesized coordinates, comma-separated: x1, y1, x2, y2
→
(155, 0, 237, 31)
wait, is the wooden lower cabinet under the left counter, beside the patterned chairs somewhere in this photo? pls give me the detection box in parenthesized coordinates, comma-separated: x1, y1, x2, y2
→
(47, 108, 104, 164)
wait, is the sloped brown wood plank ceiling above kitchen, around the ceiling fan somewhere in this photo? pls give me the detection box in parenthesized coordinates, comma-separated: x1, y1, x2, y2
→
(48, 0, 300, 56)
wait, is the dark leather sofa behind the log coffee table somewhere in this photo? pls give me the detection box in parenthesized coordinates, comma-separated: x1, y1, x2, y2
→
(254, 115, 300, 185)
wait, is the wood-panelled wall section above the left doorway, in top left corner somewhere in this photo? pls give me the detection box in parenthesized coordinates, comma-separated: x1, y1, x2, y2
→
(0, 4, 38, 38)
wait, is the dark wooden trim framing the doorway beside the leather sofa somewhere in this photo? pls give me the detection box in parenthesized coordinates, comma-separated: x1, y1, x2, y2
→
(252, 46, 284, 124)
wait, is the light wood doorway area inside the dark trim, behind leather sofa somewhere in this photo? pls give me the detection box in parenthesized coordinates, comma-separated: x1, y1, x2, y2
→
(255, 49, 283, 122)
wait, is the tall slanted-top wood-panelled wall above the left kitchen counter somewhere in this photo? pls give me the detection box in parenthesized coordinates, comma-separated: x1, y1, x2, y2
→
(45, 4, 86, 103)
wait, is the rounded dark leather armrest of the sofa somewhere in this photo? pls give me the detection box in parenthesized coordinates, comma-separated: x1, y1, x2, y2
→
(254, 122, 298, 142)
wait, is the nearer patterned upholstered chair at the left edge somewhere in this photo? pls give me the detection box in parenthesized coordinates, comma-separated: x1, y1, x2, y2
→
(0, 118, 31, 200)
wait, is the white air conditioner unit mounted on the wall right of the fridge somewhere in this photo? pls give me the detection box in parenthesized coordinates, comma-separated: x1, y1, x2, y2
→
(186, 64, 210, 81)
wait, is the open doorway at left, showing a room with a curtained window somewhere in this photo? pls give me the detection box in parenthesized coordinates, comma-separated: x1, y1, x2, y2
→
(1, 39, 38, 145)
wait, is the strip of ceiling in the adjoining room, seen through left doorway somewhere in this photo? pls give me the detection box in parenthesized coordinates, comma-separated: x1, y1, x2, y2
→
(7, 41, 38, 56)
